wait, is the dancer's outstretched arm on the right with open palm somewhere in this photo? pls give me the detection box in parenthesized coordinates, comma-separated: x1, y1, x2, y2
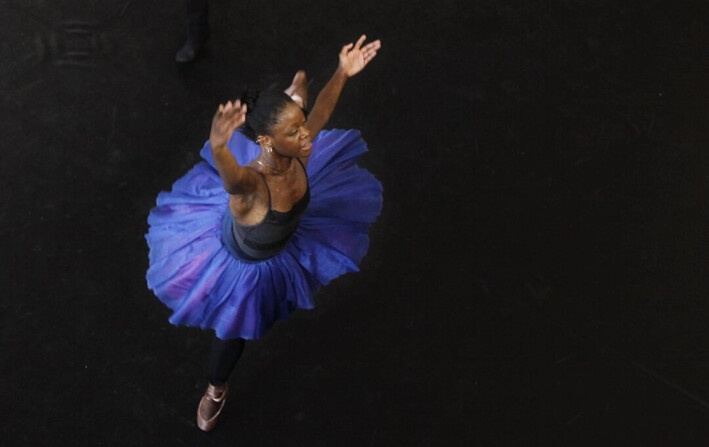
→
(307, 34, 382, 138)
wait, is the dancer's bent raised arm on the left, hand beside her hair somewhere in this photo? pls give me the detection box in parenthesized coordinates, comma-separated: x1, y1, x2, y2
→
(209, 100, 258, 194)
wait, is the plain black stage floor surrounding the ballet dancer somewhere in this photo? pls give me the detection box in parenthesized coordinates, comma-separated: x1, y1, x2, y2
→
(0, 0, 709, 446)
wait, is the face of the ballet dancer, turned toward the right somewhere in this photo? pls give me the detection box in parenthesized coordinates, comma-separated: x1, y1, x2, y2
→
(270, 103, 312, 157)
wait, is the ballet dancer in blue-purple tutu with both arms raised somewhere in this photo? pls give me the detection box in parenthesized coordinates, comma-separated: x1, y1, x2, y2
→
(146, 35, 382, 431)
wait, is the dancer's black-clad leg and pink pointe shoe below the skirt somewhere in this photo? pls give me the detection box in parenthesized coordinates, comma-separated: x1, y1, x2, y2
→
(197, 338, 246, 431)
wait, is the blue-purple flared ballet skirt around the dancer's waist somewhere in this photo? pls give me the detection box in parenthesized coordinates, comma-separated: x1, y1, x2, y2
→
(145, 130, 382, 339)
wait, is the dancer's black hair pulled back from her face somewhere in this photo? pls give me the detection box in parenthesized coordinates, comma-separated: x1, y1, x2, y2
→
(240, 89, 293, 141)
